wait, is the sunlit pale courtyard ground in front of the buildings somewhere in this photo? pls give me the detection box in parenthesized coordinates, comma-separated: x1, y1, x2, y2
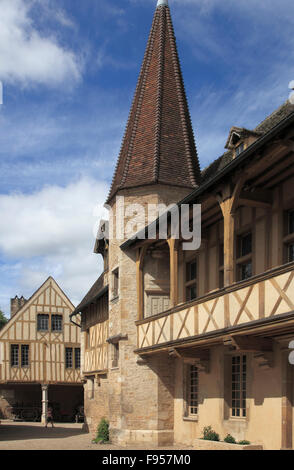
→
(0, 421, 191, 450)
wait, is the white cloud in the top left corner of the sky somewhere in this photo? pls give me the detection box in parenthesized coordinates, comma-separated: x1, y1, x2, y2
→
(0, 0, 81, 86)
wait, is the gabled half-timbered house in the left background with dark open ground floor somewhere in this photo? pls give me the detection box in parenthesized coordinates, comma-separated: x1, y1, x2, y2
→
(0, 277, 83, 420)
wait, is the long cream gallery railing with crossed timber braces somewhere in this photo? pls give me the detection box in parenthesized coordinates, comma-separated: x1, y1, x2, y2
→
(136, 263, 294, 349)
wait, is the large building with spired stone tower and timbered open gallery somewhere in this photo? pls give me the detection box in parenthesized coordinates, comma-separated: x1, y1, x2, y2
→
(73, 0, 294, 449)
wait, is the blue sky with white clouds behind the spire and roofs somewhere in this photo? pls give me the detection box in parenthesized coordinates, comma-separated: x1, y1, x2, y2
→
(0, 0, 294, 313)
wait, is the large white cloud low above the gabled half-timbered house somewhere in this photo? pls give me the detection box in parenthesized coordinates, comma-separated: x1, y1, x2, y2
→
(0, 179, 108, 310)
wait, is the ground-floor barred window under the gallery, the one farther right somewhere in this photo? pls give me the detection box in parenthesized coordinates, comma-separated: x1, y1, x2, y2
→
(232, 355, 247, 418)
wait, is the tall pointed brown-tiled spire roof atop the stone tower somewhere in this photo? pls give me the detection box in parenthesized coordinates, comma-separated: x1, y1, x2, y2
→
(107, 0, 200, 202)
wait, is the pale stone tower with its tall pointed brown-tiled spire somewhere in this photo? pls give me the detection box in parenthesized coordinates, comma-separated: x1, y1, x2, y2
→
(107, 0, 200, 445)
